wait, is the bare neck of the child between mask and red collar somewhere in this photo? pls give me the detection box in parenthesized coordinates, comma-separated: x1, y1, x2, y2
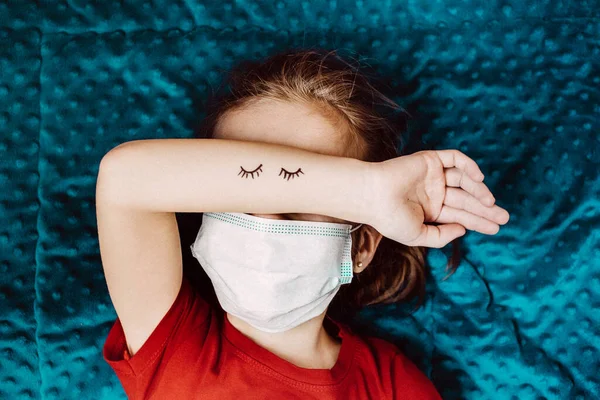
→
(225, 312, 341, 369)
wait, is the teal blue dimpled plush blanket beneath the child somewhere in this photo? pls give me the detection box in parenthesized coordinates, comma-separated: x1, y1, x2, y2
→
(0, 0, 600, 400)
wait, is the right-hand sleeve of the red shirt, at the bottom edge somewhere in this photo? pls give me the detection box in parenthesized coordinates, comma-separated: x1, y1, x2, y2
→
(392, 353, 442, 400)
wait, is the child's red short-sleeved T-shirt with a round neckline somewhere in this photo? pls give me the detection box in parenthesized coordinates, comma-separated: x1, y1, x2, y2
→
(102, 277, 441, 400)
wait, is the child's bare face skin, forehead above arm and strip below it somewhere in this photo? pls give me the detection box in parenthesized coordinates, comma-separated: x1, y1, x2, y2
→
(213, 99, 349, 228)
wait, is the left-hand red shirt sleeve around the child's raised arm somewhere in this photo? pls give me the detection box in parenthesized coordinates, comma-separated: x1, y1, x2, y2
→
(102, 276, 210, 388)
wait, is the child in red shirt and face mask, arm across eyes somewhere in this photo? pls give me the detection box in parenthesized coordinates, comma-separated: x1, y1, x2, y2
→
(96, 50, 508, 400)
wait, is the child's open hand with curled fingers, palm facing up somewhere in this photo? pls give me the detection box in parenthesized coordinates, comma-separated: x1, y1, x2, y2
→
(366, 150, 510, 248)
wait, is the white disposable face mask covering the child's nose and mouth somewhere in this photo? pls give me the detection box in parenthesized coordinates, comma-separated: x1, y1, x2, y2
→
(190, 212, 362, 332)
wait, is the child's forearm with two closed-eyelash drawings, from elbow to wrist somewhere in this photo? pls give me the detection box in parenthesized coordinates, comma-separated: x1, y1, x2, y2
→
(96, 139, 372, 222)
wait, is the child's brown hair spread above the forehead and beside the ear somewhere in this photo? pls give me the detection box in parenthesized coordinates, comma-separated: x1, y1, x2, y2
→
(195, 49, 460, 318)
